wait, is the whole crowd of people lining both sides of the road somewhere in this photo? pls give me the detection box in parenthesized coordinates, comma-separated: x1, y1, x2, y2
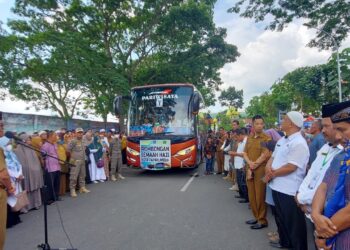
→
(0, 101, 350, 250)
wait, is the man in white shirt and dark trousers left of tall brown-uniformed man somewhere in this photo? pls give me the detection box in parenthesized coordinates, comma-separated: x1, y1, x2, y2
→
(229, 128, 249, 203)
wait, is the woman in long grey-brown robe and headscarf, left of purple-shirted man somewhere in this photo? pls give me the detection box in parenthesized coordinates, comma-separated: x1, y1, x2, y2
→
(14, 133, 44, 212)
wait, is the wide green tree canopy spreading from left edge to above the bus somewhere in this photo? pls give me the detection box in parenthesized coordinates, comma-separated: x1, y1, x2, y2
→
(0, 0, 238, 123)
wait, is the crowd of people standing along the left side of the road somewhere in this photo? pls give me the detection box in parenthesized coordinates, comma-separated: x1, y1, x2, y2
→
(0, 123, 126, 249)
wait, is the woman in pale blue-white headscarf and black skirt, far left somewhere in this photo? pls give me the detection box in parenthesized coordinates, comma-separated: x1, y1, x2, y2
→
(0, 137, 23, 228)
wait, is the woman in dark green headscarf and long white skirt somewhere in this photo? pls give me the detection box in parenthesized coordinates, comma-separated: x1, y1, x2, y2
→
(88, 136, 106, 183)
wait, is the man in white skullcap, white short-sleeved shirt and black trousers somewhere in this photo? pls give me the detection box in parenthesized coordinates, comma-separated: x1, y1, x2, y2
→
(265, 111, 310, 250)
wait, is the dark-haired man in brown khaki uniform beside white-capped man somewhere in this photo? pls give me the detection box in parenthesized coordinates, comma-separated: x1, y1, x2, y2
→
(244, 115, 271, 229)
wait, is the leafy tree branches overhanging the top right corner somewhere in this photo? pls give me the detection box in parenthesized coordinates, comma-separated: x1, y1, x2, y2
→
(228, 0, 350, 48)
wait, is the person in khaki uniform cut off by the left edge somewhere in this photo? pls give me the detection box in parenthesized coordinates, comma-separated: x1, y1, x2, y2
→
(0, 118, 15, 250)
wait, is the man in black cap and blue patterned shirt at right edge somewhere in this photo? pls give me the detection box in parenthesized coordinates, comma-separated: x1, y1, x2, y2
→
(311, 101, 350, 249)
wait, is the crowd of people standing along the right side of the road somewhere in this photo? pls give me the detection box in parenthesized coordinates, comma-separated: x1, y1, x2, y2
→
(204, 101, 350, 250)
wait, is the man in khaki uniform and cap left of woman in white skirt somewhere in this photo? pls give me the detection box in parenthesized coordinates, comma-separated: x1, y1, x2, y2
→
(67, 128, 90, 197)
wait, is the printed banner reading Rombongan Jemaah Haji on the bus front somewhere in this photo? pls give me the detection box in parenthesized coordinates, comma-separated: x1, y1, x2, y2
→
(140, 140, 171, 170)
